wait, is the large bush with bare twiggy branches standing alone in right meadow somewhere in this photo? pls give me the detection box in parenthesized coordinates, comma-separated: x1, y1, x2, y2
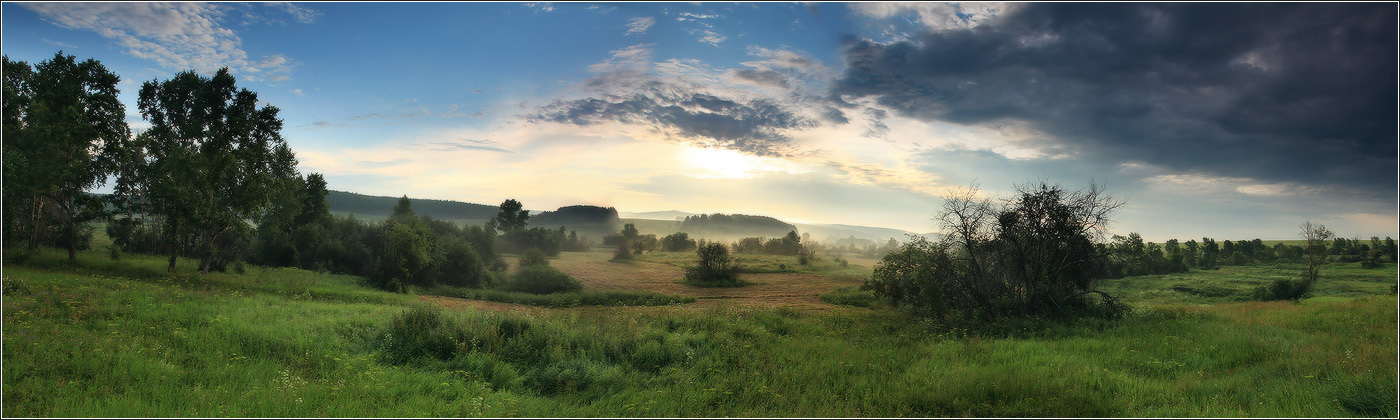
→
(869, 182, 1121, 319)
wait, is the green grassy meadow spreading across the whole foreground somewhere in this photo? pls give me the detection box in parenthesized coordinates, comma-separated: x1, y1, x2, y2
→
(3, 249, 1397, 417)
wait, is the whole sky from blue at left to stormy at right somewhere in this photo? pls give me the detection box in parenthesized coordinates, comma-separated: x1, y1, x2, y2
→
(0, 1, 1400, 242)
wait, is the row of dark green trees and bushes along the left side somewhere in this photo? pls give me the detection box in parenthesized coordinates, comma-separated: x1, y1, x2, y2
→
(3, 52, 589, 295)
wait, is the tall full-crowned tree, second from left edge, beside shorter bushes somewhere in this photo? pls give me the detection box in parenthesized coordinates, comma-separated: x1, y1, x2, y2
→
(137, 67, 295, 273)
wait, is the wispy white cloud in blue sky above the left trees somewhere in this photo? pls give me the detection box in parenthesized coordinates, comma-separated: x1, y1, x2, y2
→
(21, 3, 294, 81)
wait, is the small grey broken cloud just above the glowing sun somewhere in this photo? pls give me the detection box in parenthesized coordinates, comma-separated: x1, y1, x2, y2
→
(526, 83, 816, 157)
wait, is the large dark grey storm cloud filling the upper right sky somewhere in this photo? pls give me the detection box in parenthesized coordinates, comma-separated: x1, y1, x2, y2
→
(833, 3, 1397, 195)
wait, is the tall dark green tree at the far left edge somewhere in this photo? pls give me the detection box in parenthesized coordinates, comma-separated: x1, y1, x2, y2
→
(6, 52, 130, 260)
